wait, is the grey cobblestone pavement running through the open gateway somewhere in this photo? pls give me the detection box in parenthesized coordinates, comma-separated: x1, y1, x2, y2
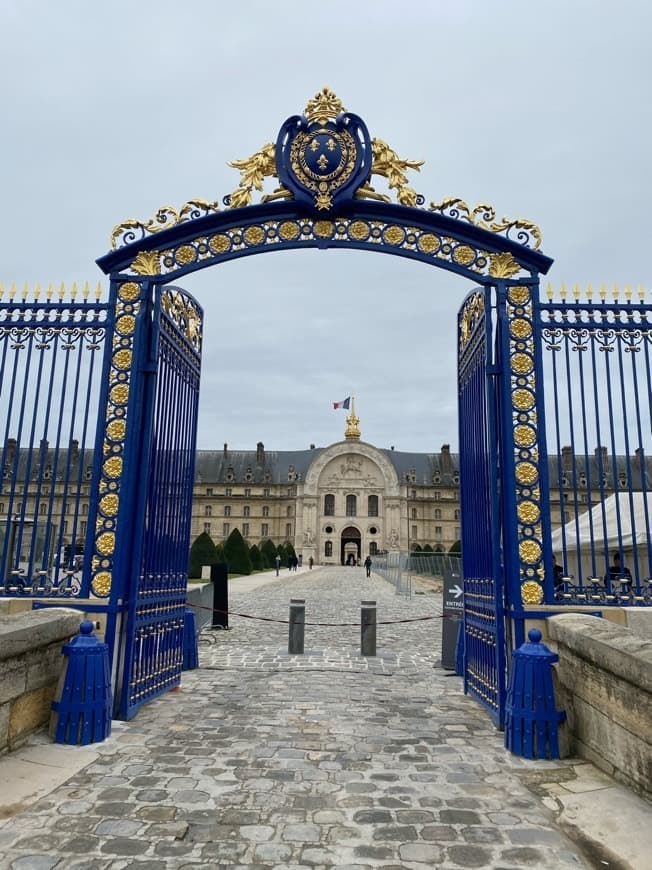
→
(0, 568, 589, 870)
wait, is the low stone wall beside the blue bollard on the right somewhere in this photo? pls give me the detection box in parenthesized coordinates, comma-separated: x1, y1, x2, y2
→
(547, 613, 652, 799)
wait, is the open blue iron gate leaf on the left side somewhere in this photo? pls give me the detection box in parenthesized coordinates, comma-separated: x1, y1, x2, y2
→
(114, 286, 203, 718)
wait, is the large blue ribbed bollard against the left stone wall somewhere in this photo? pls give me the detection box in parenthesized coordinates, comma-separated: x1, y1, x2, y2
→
(50, 620, 113, 746)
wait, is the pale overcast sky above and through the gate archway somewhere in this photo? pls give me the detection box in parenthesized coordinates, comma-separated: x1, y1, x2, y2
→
(0, 0, 652, 451)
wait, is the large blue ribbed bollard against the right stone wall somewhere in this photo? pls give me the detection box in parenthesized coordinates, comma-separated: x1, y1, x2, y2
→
(505, 628, 566, 758)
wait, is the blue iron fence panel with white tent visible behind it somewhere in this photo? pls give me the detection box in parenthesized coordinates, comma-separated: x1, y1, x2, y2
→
(538, 291, 652, 605)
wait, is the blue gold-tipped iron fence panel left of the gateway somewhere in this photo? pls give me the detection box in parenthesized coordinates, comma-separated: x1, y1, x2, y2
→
(0, 287, 113, 598)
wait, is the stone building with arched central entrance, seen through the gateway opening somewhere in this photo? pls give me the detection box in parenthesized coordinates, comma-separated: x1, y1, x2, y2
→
(192, 410, 460, 564)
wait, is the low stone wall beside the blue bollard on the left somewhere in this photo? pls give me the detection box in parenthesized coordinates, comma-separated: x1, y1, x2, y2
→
(0, 607, 84, 752)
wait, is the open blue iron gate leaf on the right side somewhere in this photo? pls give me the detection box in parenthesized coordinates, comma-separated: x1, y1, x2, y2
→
(458, 288, 505, 727)
